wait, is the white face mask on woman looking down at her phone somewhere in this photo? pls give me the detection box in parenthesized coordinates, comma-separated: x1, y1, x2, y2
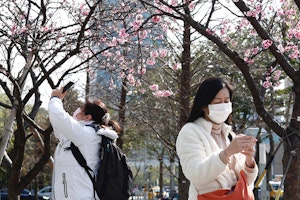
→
(208, 102, 232, 124)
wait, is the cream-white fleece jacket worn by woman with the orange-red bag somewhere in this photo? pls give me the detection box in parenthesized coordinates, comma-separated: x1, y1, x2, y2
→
(176, 118, 258, 200)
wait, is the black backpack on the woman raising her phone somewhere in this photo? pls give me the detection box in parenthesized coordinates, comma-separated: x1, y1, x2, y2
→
(70, 132, 133, 200)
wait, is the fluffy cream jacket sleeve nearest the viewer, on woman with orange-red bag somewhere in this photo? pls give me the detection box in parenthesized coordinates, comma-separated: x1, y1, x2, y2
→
(176, 124, 226, 185)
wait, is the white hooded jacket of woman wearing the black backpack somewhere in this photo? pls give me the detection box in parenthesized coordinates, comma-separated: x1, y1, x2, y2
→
(48, 97, 118, 200)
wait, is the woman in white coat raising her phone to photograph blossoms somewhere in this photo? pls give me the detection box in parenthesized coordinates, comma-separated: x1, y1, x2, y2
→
(48, 88, 120, 200)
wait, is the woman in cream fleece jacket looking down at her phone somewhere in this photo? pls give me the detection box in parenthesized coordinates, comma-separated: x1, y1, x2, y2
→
(176, 77, 258, 200)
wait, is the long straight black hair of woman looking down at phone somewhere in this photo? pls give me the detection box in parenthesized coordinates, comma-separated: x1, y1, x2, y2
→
(187, 77, 233, 122)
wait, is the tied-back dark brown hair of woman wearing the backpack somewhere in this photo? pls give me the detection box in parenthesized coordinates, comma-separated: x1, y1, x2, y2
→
(82, 100, 121, 133)
